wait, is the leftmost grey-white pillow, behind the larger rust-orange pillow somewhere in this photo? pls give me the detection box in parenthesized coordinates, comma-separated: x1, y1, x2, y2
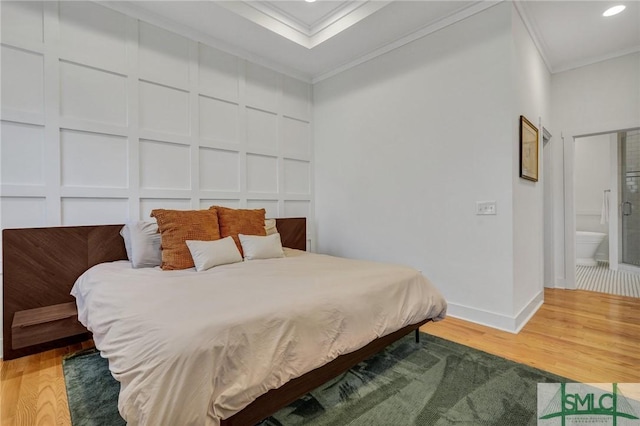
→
(120, 222, 162, 268)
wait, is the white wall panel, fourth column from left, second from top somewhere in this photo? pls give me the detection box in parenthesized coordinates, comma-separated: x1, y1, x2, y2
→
(199, 96, 238, 143)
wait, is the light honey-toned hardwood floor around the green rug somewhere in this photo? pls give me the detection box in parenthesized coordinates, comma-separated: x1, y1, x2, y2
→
(0, 289, 640, 426)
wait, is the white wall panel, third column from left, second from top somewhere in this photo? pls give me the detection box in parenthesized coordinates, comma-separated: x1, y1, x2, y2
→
(140, 81, 189, 135)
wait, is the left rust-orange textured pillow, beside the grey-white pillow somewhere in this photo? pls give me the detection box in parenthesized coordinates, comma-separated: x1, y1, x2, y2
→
(151, 209, 220, 270)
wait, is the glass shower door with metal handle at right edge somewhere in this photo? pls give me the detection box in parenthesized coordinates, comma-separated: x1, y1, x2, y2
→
(620, 130, 640, 266)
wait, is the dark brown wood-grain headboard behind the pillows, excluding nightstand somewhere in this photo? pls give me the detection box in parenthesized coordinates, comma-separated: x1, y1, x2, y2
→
(2, 218, 307, 360)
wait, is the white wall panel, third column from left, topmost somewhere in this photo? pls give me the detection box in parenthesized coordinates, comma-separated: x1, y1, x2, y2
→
(138, 22, 190, 88)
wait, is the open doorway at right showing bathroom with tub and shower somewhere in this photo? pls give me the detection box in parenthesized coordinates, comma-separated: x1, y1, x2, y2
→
(574, 129, 640, 297)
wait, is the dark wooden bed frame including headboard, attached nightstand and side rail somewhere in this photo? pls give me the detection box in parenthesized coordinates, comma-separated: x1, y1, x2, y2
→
(2, 218, 429, 426)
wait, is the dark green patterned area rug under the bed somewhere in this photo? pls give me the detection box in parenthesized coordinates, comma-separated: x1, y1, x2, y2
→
(63, 333, 567, 426)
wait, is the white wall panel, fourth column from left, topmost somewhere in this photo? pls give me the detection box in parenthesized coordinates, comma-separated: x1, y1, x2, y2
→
(198, 43, 239, 102)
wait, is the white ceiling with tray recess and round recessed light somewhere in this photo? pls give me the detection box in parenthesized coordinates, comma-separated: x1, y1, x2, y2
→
(101, 0, 640, 81)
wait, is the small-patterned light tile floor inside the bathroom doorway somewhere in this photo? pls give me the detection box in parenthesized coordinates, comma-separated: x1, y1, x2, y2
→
(576, 261, 640, 297)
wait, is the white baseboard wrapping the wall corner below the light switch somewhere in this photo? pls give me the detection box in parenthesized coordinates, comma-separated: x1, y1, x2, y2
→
(447, 291, 544, 334)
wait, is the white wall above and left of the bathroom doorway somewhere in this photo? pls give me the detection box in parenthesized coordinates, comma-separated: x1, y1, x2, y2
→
(551, 53, 640, 287)
